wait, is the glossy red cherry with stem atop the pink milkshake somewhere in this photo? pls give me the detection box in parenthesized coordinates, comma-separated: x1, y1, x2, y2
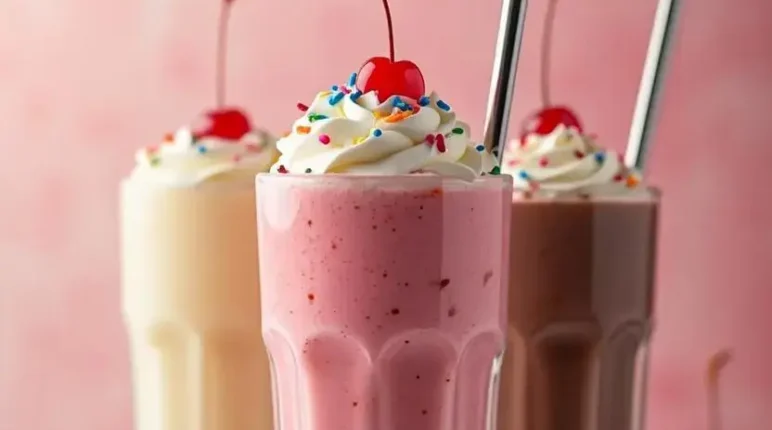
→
(356, 0, 426, 102)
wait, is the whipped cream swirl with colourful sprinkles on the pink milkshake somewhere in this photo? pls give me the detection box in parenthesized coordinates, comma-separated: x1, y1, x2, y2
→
(271, 86, 498, 181)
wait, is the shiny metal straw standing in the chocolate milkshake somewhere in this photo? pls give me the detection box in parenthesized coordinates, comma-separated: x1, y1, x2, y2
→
(625, 0, 679, 171)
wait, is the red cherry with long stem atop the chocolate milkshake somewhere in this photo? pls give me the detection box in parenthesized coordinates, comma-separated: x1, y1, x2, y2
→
(522, 0, 583, 137)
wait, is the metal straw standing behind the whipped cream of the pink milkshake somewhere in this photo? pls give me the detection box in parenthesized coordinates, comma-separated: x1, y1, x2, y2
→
(484, 0, 528, 162)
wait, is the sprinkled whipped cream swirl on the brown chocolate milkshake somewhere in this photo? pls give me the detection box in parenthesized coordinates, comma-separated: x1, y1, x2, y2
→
(502, 125, 643, 196)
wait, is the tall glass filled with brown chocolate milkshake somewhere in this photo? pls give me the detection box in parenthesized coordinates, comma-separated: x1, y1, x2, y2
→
(499, 189, 659, 430)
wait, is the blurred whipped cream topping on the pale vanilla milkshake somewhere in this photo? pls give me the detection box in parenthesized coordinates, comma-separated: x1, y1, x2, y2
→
(131, 127, 279, 186)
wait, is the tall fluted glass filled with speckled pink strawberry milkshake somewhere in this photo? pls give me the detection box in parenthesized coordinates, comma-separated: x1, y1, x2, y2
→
(257, 175, 512, 430)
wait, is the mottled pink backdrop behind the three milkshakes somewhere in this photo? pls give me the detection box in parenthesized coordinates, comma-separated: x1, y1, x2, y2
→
(0, 0, 772, 430)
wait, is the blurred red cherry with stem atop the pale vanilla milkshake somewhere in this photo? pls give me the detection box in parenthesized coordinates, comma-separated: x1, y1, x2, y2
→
(193, 0, 252, 140)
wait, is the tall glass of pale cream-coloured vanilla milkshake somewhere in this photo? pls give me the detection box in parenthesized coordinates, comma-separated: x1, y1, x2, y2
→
(121, 180, 272, 430)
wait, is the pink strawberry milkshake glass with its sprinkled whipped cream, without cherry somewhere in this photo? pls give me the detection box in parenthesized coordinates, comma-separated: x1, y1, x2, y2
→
(257, 66, 512, 430)
